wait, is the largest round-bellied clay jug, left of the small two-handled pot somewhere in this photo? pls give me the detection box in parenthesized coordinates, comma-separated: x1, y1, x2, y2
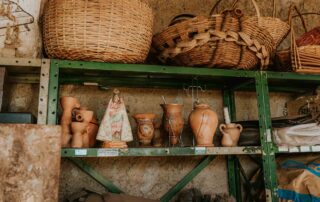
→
(189, 104, 218, 147)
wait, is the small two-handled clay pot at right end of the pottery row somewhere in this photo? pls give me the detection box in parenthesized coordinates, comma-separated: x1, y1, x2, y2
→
(219, 123, 243, 147)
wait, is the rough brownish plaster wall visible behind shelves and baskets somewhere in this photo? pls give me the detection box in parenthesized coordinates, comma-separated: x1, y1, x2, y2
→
(4, 0, 320, 199)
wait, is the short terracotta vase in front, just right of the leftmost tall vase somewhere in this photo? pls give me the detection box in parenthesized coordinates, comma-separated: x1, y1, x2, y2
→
(71, 122, 88, 148)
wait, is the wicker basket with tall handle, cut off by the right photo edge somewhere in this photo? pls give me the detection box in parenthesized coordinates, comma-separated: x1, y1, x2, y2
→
(289, 6, 320, 74)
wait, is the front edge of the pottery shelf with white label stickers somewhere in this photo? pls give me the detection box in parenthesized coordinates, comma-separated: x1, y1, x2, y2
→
(61, 146, 261, 157)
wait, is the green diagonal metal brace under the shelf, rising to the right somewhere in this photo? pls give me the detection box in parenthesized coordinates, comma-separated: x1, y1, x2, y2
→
(160, 156, 215, 202)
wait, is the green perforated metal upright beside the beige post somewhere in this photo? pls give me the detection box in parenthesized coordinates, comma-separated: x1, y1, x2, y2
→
(47, 60, 59, 125)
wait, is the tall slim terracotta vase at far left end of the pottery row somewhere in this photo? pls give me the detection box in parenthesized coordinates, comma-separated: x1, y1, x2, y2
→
(60, 96, 80, 147)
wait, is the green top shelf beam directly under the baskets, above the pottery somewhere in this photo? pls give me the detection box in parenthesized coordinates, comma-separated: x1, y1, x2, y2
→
(53, 60, 255, 78)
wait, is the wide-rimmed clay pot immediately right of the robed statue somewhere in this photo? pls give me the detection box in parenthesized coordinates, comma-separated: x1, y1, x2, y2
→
(133, 114, 156, 146)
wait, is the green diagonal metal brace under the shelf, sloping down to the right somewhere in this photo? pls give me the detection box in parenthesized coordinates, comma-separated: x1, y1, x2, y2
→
(69, 158, 123, 194)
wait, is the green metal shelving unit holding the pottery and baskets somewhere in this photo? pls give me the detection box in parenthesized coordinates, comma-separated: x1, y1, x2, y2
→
(0, 58, 320, 201)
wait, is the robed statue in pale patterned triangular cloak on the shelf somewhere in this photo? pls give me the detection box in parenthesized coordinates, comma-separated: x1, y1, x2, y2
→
(97, 89, 133, 148)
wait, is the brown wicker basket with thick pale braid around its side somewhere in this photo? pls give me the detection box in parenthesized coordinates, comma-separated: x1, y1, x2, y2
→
(153, 0, 274, 69)
